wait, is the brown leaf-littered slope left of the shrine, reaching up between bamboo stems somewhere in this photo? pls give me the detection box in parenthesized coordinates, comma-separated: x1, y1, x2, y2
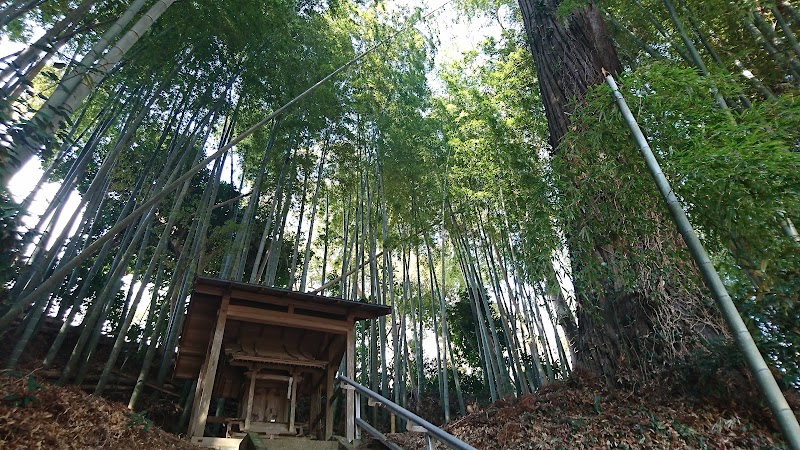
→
(0, 323, 199, 450)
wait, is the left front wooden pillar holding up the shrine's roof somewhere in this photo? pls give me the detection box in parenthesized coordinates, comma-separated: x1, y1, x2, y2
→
(188, 292, 231, 437)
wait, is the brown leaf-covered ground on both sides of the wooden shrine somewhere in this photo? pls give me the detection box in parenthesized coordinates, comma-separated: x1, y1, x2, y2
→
(0, 373, 797, 450)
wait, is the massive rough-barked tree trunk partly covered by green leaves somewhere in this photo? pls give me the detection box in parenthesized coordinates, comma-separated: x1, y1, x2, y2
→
(519, 0, 721, 384)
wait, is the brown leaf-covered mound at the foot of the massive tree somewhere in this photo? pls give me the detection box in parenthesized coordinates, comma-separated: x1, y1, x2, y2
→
(389, 373, 800, 450)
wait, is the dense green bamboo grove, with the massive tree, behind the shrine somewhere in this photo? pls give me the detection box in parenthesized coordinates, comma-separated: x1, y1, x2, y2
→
(0, 0, 800, 446)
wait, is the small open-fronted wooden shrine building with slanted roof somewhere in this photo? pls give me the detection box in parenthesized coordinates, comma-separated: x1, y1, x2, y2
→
(175, 277, 391, 448)
